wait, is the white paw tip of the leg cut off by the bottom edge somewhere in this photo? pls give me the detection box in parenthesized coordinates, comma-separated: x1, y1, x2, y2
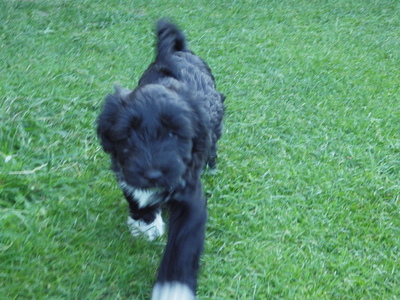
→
(151, 282, 196, 300)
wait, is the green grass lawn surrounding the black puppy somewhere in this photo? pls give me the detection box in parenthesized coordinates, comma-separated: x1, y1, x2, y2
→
(0, 0, 400, 300)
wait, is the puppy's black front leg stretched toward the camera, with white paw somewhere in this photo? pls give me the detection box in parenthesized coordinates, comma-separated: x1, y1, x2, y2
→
(152, 180, 207, 300)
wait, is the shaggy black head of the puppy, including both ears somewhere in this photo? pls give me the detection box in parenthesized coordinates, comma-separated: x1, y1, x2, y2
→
(98, 84, 210, 189)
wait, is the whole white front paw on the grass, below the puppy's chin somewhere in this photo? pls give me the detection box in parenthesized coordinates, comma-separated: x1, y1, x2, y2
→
(128, 212, 165, 241)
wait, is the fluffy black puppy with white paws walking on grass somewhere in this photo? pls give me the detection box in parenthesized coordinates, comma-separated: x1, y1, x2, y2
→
(98, 20, 224, 300)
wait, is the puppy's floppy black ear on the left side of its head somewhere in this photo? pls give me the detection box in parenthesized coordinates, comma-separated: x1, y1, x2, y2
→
(97, 87, 130, 153)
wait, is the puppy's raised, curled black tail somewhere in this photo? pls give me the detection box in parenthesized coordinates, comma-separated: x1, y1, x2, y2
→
(157, 19, 189, 61)
